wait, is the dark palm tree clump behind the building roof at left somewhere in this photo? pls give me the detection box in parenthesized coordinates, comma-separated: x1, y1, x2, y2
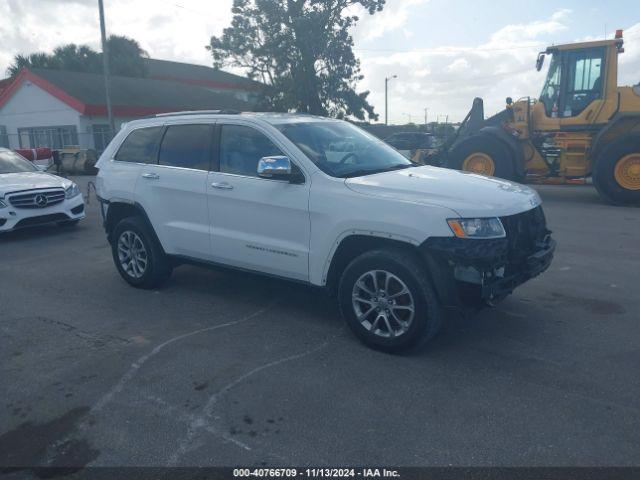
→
(7, 35, 148, 77)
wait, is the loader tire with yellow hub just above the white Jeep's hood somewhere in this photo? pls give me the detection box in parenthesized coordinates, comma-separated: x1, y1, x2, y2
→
(447, 135, 517, 180)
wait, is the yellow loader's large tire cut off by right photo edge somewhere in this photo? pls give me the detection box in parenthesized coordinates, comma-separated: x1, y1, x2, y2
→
(593, 137, 640, 205)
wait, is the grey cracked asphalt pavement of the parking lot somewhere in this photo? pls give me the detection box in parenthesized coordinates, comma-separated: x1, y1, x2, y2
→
(0, 177, 640, 466)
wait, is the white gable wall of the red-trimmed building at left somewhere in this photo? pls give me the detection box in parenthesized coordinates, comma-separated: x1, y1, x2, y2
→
(0, 81, 81, 148)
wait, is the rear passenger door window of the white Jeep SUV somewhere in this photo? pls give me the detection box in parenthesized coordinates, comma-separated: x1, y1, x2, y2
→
(158, 124, 213, 170)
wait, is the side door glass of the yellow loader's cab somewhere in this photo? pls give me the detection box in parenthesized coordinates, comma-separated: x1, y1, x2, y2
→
(562, 49, 604, 117)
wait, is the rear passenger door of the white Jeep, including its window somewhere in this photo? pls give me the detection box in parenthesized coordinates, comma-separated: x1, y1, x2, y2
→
(136, 123, 213, 259)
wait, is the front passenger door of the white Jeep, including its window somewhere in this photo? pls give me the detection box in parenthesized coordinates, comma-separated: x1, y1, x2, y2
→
(207, 123, 310, 281)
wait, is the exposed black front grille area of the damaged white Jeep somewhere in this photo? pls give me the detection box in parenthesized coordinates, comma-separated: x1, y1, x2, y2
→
(500, 206, 551, 260)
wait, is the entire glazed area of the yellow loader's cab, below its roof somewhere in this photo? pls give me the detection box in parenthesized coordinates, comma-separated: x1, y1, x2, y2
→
(540, 47, 606, 118)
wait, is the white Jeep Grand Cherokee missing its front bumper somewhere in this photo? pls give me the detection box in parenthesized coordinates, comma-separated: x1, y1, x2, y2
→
(97, 112, 554, 350)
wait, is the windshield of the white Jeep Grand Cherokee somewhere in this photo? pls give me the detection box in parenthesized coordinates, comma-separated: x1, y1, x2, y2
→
(276, 121, 413, 178)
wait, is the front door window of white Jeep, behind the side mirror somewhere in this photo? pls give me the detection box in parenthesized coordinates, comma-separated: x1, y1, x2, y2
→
(220, 125, 283, 177)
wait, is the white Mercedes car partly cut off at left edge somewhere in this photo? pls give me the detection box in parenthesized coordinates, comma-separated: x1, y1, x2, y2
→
(0, 148, 85, 233)
